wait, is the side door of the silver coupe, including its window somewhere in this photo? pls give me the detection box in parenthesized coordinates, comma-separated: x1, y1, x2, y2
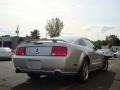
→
(84, 39, 102, 68)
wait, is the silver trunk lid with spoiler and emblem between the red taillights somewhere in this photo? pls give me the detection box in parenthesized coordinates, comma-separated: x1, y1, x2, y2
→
(20, 39, 66, 56)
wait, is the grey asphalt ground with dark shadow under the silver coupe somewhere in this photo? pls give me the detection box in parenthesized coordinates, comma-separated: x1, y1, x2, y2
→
(0, 59, 120, 90)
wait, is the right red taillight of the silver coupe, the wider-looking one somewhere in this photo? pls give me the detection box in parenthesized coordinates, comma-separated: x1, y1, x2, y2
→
(51, 46, 68, 56)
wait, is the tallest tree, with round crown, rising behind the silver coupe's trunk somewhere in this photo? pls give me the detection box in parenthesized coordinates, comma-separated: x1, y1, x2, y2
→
(46, 18, 64, 37)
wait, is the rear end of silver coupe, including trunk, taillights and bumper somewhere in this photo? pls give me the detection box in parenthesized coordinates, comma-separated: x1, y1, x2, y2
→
(13, 40, 75, 74)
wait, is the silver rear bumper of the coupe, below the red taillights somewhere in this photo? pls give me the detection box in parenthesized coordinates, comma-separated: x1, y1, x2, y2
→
(13, 56, 76, 75)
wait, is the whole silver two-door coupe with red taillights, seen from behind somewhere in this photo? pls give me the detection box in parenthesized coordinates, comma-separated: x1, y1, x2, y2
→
(13, 36, 108, 81)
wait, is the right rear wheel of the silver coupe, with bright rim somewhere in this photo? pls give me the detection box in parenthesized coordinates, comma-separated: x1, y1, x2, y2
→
(78, 60, 89, 82)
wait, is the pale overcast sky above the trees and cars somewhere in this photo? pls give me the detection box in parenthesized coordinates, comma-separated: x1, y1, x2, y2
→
(0, 0, 120, 40)
